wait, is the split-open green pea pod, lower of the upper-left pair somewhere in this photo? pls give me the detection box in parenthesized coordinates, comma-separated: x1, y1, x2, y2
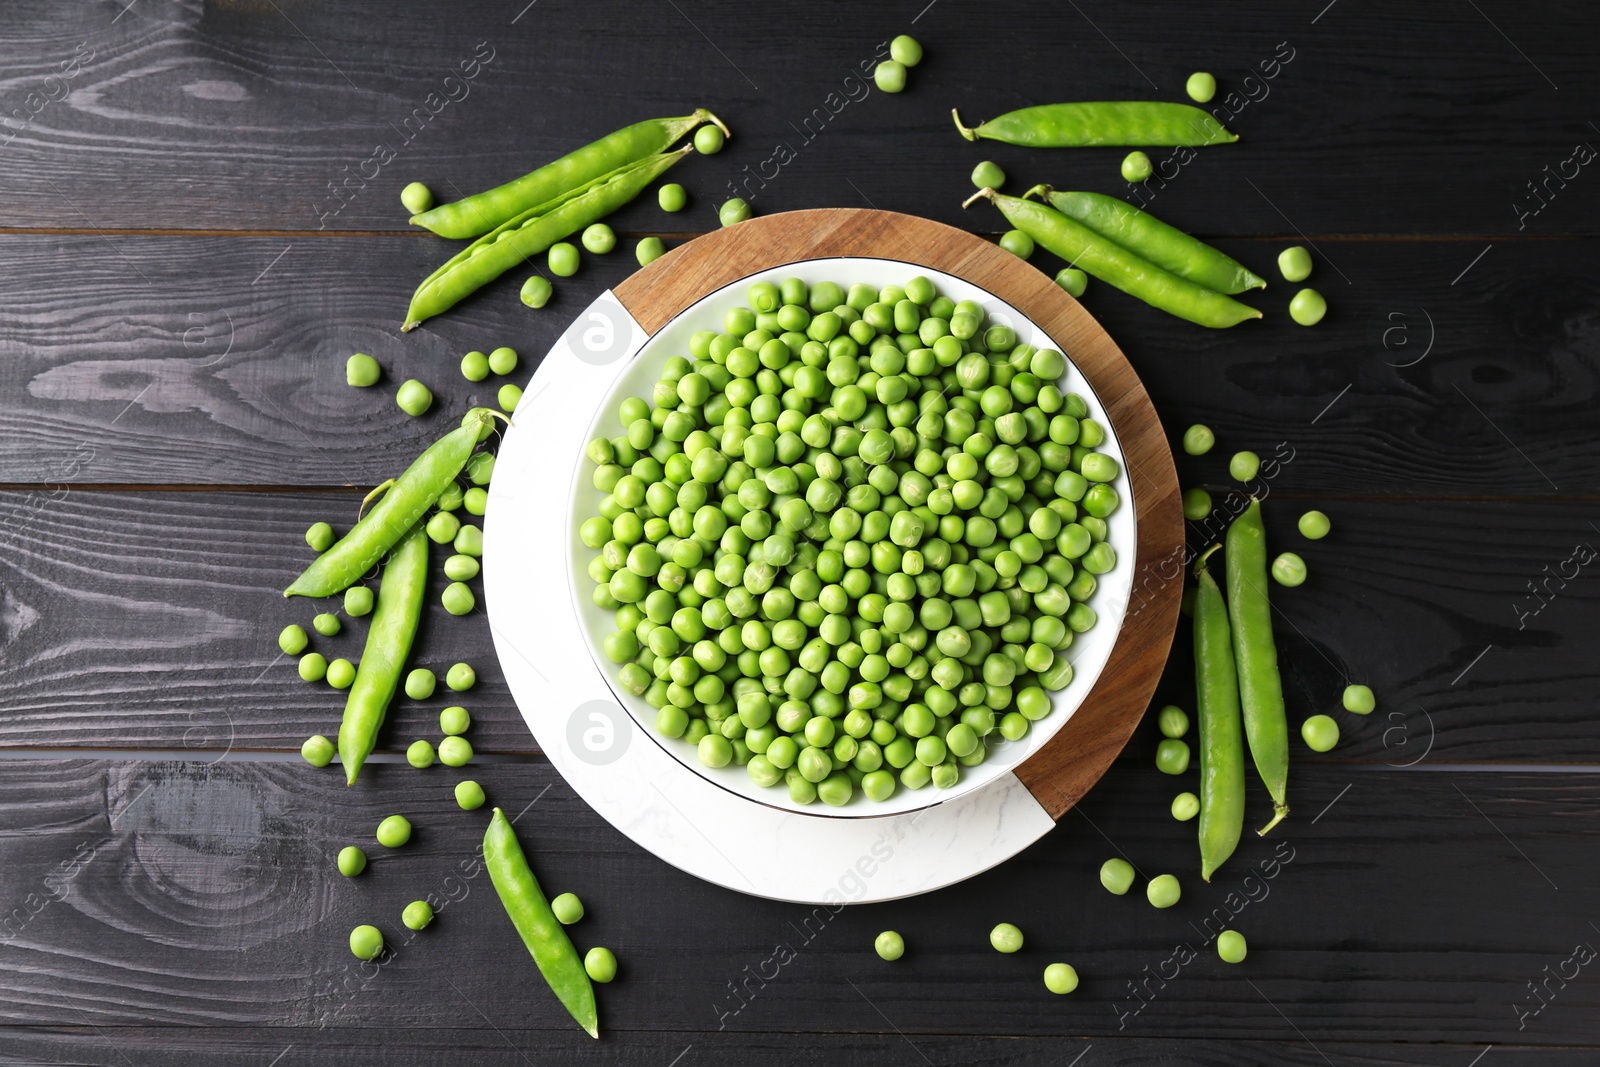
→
(400, 144, 694, 331)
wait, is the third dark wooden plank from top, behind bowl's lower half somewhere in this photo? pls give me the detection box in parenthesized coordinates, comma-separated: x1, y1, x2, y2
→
(0, 489, 1600, 766)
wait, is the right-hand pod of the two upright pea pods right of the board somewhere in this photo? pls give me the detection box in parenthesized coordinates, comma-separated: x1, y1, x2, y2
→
(1226, 501, 1290, 833)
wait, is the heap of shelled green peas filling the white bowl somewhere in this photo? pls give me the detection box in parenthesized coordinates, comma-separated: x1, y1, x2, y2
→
(579, 277, 1122, 806)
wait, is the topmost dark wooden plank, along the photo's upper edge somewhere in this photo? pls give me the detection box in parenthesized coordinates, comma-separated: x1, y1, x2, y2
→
(0, 0, 1600, 235)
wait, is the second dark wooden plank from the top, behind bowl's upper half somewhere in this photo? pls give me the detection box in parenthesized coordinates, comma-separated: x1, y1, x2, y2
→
(0, 231, 1600, 496)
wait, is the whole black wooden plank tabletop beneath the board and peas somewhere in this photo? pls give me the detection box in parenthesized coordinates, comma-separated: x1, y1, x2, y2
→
(0, 0, 1600, 1067)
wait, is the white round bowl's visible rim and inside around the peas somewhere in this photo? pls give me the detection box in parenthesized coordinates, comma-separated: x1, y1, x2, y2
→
(566, 258, 1136, 819)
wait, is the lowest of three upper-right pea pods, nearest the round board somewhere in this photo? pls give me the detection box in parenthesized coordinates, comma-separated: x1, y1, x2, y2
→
(966, 189, 1261, 330)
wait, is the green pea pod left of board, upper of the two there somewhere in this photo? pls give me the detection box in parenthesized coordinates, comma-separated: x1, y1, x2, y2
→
(283, 408, 494, 597)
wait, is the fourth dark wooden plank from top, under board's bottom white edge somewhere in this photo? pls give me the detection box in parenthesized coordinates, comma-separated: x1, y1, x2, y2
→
(0, 761, 1600, 1043)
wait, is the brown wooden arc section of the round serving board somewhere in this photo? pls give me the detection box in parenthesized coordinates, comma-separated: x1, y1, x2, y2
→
(614, 208, 1184, 819)
